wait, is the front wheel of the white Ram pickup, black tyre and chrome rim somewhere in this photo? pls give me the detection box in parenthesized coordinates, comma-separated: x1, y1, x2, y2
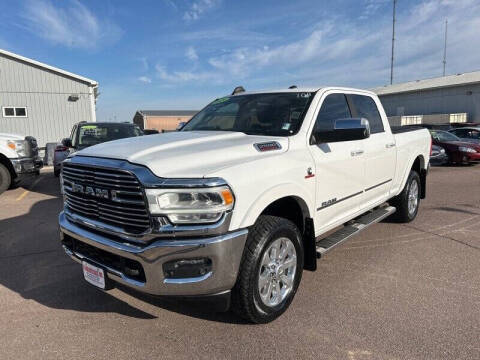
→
(232, 215, 304, 323)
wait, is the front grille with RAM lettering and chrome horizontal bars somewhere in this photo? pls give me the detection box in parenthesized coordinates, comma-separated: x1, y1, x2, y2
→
(62, 162, 150, 235)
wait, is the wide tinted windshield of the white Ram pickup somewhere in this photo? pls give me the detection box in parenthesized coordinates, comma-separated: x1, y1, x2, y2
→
(181, 92, 314, 136)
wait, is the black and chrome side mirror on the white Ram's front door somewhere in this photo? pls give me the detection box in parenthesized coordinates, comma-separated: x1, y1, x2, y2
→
(312, 118, 370, 144)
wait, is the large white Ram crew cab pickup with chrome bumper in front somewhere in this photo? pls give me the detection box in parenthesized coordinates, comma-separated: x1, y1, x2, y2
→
(59, 87, 431, 323)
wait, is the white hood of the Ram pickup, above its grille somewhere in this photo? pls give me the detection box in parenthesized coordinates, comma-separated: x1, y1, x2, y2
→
(76, 131, 288, 178)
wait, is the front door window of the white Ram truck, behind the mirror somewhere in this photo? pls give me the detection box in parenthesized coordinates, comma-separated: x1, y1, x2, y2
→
(314, 94, 352, 131)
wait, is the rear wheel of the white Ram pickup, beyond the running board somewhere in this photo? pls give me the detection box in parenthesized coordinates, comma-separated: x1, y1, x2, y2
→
(390, 170, 421, 223)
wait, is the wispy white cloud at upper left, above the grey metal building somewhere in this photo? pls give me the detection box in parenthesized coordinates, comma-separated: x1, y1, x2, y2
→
(22, 0, 122, 49)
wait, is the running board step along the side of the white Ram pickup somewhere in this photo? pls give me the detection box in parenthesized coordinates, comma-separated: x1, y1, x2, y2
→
(316, 206, 396, 258)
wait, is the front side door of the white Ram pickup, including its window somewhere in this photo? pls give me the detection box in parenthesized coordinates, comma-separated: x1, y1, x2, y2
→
(309, 91, 365, 231)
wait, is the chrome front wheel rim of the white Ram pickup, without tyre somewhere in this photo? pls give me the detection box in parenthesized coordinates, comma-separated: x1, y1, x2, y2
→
(258, 237, 297, 307)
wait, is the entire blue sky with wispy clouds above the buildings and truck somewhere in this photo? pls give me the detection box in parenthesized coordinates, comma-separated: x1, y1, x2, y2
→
(0, 0, 480, 121)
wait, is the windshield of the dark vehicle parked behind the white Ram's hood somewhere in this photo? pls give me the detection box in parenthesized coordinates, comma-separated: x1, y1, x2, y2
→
(77, 124, 142, 148)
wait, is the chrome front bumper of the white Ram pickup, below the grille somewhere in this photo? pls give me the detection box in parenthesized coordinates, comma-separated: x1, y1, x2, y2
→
(59, 212, 248, 296)
